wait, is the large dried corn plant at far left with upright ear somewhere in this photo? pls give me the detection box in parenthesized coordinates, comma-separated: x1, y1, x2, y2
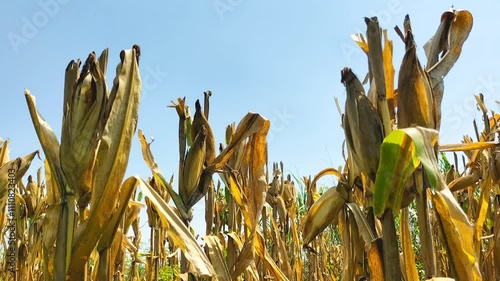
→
(22, 46, 141, 280)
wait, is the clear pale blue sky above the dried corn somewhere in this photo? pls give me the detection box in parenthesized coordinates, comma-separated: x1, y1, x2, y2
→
(0, 0, 500, 234)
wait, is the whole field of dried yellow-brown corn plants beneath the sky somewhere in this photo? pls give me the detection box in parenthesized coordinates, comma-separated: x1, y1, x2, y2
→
(0, 9, 500, 281)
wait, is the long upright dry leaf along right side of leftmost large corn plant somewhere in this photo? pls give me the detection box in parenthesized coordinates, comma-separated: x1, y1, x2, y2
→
(69, 46, 141, 278)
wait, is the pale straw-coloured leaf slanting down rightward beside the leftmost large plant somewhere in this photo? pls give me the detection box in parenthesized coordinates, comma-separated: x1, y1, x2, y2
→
(140, 177, 216, 277)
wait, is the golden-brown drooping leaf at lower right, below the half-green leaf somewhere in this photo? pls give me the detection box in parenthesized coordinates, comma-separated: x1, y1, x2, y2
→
(429, 188, 482, 281)
